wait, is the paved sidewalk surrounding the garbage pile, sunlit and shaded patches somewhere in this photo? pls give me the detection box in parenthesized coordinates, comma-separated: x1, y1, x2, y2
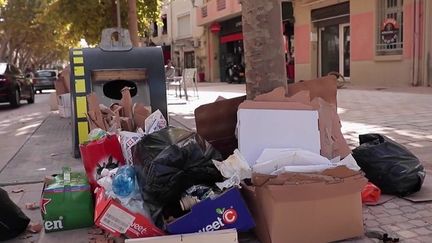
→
(0, 83, 432, 243)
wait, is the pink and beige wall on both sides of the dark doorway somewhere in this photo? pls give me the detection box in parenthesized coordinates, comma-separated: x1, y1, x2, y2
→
(293, 0, 418, 86)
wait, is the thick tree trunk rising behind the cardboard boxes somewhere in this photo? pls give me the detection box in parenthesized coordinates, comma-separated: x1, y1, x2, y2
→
(242, 0, 287, 99)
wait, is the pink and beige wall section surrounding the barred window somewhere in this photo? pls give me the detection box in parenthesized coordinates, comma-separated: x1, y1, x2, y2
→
(350, 0, 413, 86)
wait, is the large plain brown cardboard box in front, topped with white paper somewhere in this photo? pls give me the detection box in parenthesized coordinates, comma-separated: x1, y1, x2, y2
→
(243, 167, 367, 243)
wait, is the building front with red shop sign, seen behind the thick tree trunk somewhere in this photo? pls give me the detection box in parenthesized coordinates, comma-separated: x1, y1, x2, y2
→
(196, 0, 294, 82)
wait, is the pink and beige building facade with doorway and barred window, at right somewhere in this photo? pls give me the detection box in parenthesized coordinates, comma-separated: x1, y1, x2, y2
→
(293, 0, 432, 86)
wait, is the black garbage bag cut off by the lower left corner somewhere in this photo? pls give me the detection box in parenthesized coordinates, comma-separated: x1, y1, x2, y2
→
(0, 188, 30, 241)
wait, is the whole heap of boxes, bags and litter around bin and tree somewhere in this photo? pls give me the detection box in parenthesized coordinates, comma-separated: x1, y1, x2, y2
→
(33, 78, 425, 243)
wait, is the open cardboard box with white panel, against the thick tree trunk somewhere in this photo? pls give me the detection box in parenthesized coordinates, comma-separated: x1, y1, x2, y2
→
(238, 87, 351, 165)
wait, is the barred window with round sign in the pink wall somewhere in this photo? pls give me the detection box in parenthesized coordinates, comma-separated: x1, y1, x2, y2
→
(376, 0, 403, 55)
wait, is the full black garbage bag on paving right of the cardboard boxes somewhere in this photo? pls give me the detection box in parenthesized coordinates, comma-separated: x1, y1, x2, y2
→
(352, 134, 426, 197)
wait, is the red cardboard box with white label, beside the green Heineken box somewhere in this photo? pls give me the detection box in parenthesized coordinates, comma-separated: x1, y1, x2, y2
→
(94, 188, 164, 238)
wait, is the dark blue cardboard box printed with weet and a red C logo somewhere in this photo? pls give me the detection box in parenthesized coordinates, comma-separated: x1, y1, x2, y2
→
(167, 188, 255, 234)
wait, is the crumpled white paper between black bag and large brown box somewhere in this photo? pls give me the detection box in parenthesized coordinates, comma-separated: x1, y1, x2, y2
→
(213, 149, 252, 190)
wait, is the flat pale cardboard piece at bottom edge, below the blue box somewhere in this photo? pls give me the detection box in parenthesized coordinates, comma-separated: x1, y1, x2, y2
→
(126, 229, 238, 243)
